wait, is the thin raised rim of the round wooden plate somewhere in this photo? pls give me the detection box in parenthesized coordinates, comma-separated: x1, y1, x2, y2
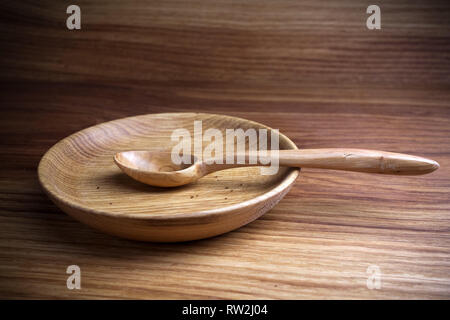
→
(37, 112, 300, 221)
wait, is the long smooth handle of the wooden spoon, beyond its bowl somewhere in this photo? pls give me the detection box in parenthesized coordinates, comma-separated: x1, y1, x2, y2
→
(270, 148, 439, 175)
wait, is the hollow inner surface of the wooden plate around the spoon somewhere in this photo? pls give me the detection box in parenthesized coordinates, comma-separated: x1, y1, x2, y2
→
(39, 113, 294, 215)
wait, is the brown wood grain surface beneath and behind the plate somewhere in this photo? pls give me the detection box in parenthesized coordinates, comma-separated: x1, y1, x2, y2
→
(0, 0, 450, 299)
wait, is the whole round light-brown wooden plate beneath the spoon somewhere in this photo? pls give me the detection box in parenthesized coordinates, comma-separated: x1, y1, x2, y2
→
(38, 113, 299, 242)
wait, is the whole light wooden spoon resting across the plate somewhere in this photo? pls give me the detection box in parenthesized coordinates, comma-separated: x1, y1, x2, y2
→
(114, 148, 439, 187)
